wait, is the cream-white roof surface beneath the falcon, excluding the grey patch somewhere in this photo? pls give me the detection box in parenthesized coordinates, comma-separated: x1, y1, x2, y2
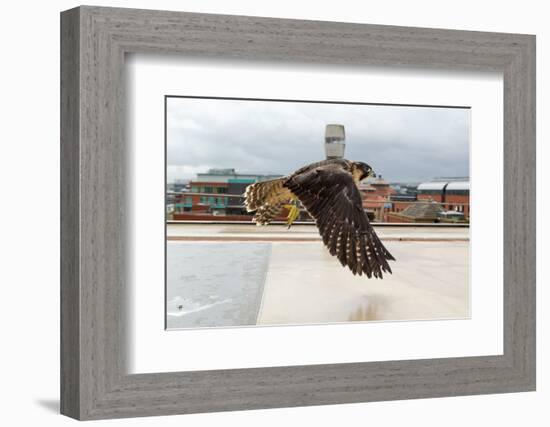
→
(167, 223, 470, 325)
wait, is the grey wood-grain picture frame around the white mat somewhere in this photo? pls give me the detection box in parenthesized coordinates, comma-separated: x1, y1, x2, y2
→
(61, 6, 535, 419)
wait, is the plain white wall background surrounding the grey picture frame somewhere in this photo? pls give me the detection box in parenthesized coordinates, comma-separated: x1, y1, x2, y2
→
(0, 0, 550, 427)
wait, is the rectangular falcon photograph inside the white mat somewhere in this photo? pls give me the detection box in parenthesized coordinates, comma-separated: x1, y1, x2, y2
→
(165, 95, 470, 330)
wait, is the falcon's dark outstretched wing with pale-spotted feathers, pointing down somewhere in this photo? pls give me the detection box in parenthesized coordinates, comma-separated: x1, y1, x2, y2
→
(284, 164, 395, 278)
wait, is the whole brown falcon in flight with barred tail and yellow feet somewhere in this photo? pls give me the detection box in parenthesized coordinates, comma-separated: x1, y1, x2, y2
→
(244, 159, 395, 279)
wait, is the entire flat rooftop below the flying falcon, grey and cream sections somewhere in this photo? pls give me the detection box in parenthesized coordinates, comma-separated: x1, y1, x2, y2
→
(167, 223, 470, 329)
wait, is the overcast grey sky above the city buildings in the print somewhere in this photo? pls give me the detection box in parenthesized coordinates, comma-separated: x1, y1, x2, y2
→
(167, 98, 470, 182)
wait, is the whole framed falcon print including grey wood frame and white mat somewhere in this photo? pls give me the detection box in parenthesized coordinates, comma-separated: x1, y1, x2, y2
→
(61, 6, 535, 419)
